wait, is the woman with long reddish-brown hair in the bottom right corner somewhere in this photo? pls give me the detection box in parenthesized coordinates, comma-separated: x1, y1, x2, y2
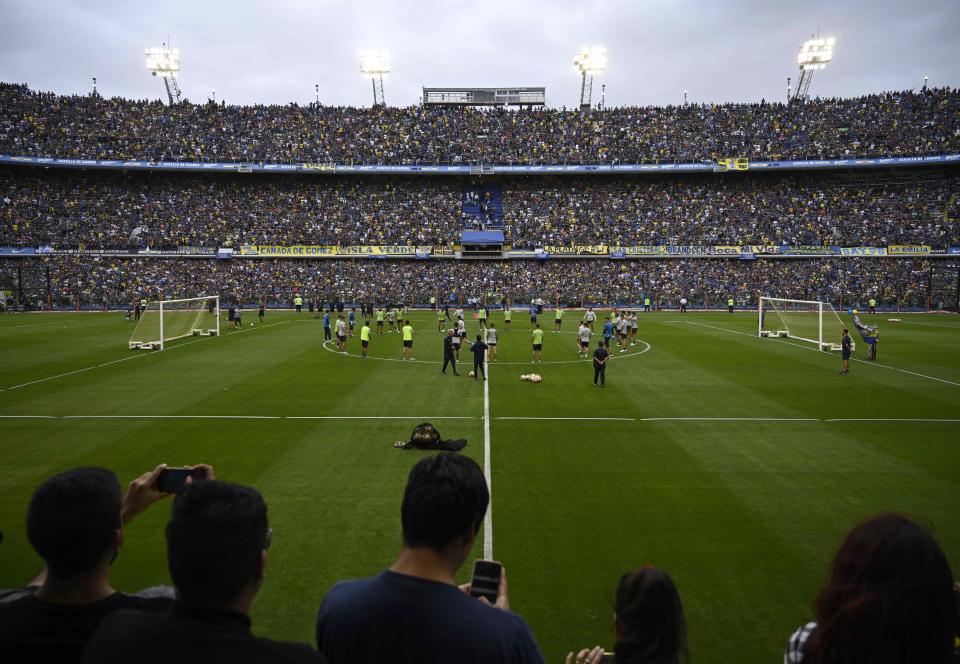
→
(784, 514, 960, 664)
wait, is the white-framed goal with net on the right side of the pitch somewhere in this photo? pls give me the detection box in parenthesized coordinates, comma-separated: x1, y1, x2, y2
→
(757, 297, 844, 350)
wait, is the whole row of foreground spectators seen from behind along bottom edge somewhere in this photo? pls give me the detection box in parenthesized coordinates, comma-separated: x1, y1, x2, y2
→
(0, 460, 960, 664)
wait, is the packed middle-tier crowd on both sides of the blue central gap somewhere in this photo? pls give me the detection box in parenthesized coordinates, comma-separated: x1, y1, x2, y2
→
(0, 168, 960, 248)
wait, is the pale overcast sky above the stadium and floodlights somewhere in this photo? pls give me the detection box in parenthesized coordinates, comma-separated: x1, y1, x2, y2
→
(0, 0, 960, 107)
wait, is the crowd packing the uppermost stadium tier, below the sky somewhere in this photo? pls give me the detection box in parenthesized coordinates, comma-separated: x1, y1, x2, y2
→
(0, 83, 960, 164)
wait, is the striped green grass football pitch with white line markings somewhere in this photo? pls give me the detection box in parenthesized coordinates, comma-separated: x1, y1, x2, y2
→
(0, 312, 960, 662)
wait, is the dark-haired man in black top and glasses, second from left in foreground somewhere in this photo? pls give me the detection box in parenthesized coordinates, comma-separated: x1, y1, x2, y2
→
(83, 481, 324, 664)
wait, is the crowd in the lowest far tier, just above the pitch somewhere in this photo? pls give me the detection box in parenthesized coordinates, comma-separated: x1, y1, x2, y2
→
(0, 256, 958, 308)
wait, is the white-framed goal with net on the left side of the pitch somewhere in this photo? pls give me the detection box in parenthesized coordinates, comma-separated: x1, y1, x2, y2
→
(129, 295, 220, 350)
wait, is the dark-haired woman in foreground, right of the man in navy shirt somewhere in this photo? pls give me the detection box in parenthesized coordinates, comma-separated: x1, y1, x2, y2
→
(567, 565, 687, 664)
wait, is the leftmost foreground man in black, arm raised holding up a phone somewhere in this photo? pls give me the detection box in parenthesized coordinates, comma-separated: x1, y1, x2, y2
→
(0, 465, 191, 662)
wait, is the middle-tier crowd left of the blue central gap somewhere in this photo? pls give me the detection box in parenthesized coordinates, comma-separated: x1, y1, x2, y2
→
(0, 169, 460, 247)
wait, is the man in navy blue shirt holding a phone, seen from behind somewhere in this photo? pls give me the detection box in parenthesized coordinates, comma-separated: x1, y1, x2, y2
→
(317, 454, 543, 664)
